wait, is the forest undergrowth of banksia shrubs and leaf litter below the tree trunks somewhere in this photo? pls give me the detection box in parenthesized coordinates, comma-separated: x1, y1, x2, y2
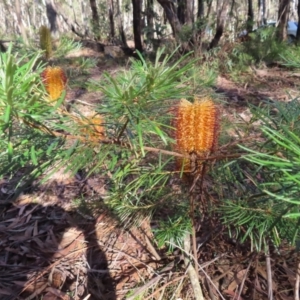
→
(0, 35, 300, 300)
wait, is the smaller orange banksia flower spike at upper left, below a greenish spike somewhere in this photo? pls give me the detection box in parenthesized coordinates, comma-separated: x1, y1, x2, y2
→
(42, 67, 67, 101)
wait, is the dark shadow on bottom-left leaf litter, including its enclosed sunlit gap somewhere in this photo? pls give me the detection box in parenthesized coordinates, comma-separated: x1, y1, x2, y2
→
(0, 179, 116, 300)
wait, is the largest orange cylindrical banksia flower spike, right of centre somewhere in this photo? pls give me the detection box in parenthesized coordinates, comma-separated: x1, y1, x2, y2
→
(175, 98, 219, 172)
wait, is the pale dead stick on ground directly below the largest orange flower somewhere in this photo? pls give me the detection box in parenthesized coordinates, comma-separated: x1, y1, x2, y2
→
(183, 233, 204, 300)
